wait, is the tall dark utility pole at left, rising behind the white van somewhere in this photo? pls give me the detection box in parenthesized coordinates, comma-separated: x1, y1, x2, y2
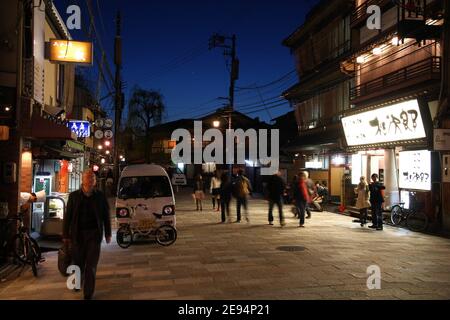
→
(114, 11, 124, 187)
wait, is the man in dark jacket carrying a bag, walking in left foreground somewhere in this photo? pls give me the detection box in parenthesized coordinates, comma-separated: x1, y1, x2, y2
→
(63, 170, 111, 300)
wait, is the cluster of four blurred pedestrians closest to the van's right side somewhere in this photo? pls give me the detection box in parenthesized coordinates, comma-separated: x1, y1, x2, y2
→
(193, 170, 252, 223)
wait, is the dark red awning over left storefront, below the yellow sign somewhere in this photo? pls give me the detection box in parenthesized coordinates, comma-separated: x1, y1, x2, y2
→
(31, 114, 72, 140)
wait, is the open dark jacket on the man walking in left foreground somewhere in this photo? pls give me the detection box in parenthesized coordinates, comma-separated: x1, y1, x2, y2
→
(63, 189, 111, 243)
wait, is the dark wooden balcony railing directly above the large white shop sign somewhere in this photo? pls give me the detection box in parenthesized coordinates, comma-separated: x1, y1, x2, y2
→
(350, 57, 441, 104)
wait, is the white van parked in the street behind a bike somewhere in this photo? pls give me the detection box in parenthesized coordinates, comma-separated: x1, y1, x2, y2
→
(116, 164, 176, 227)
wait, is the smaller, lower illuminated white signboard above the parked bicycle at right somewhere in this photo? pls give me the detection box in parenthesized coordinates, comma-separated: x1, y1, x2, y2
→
(399, 150, 431, 191)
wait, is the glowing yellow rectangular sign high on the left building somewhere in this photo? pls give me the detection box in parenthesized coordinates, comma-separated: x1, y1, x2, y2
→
(49, 39, 93, 64)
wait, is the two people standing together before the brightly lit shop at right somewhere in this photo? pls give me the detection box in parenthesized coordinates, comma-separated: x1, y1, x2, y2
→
(355, 173, 386, 231)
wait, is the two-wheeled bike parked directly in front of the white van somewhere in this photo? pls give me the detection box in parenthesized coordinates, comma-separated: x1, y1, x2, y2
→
(116, 213, 177, 249)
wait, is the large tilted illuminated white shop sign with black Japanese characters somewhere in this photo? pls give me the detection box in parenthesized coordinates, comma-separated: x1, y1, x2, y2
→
(342, 100, 426, 146)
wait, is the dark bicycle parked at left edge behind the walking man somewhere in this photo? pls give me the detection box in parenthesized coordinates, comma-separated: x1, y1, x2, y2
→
(8, 213, 42, 277)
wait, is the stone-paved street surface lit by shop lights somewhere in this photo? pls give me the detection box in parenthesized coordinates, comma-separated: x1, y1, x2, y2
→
(0, 193, 450, 300)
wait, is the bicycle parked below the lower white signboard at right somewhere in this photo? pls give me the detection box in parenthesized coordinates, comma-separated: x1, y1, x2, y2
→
(391, 196, 428, 232)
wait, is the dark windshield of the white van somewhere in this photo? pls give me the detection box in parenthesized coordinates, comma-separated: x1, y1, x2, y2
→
(118, 176, 172, 199)
